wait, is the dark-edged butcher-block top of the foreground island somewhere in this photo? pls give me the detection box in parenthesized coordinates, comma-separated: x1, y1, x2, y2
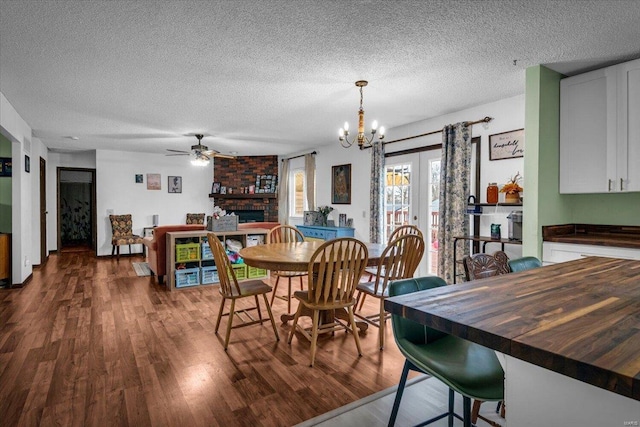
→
(385, 257, 640, 400)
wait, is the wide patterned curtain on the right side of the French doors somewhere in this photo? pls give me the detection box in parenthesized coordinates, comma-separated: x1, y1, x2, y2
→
(438, 123, 471, 283)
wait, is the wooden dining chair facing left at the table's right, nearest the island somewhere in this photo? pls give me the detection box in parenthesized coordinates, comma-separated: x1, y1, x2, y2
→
(355, 233, 424, 350)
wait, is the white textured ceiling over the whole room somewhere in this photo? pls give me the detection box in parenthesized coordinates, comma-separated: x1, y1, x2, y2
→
(0, 0, 640, 155)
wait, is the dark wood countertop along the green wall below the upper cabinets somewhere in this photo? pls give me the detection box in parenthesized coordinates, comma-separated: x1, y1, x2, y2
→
(542, 224, 640, 249)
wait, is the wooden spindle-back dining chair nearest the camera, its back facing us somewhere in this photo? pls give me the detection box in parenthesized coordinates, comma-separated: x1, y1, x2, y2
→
(288, 237, 369, 367)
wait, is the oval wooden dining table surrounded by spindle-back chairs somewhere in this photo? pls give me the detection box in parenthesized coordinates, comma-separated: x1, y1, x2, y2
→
(239, 240, 386, 332)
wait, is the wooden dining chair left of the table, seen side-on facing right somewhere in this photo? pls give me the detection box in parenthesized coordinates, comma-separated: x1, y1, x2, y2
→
(207, 233, 280, 351)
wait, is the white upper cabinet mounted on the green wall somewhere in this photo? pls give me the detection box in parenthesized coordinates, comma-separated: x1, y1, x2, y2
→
(560, 60, 640, 193)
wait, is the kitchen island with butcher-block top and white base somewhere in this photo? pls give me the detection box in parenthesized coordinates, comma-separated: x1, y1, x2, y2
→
(385, 257, 640, 427)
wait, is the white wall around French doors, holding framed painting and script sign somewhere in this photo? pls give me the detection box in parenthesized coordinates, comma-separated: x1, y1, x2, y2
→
(316, 95, 526, 257)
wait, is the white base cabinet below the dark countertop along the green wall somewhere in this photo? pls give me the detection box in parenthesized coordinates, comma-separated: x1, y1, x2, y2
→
(542, 242, 640, 265)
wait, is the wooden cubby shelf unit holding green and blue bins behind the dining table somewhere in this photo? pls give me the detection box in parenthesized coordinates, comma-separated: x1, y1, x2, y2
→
(167, 228, 269, 291)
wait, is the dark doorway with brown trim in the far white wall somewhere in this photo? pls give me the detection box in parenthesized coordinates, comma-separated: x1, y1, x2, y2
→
(57, 167, 97, 253)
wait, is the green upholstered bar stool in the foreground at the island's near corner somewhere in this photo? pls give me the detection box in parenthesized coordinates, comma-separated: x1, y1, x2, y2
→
(389, 276, 504, 426)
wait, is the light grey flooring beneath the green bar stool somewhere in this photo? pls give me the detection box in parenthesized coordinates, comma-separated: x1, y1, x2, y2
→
(296, 375, 505, 427)
